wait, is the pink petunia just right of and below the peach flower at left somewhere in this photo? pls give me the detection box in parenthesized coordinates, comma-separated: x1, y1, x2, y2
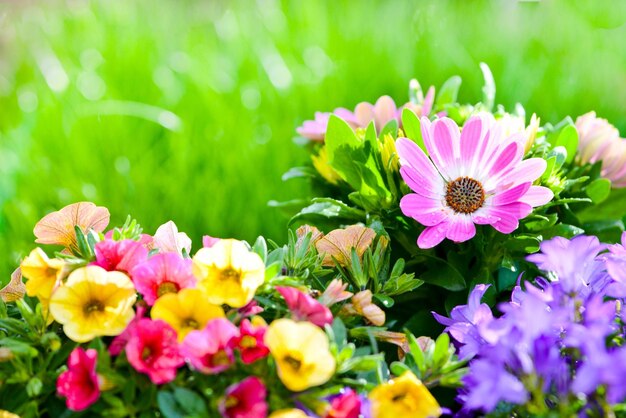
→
(91, 239, 148, 278)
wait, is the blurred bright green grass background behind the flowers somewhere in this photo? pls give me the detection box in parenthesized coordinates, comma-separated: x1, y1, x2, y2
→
(0, 0, 626, 282)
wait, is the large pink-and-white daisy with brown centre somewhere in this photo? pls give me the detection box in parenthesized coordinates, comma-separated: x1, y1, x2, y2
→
(396, 116, 554, 248)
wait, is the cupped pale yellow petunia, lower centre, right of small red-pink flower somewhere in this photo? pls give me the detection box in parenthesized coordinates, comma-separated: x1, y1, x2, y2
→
(265, 318, 335, 392)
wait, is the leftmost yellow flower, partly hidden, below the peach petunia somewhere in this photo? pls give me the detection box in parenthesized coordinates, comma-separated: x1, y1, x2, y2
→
(20, 248, 65, 305)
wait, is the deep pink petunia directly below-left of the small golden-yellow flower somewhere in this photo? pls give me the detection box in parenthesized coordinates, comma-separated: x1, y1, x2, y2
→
(126, 318, 185, 385)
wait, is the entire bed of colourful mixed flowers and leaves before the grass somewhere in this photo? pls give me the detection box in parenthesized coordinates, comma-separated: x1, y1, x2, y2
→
(0, 65, 626, 418)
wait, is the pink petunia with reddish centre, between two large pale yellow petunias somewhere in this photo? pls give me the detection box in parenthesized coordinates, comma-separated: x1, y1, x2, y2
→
(132, 252, 196, 306)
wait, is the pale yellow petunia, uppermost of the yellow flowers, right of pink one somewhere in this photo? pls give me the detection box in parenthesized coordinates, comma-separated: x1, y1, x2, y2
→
(193, 239, 265, 308)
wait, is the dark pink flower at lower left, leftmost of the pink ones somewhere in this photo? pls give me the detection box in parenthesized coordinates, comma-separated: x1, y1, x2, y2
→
(57, 347, 100, 411)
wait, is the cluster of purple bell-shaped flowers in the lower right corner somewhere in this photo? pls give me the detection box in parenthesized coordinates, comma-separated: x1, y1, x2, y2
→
(434, 233, 626, 415)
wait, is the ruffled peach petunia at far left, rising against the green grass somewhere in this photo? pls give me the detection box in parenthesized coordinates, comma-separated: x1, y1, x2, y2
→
(33, 202, 110, 251)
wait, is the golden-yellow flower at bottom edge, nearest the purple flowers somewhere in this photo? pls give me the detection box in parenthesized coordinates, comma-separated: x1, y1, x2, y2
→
(369, 372, 441, 418)
